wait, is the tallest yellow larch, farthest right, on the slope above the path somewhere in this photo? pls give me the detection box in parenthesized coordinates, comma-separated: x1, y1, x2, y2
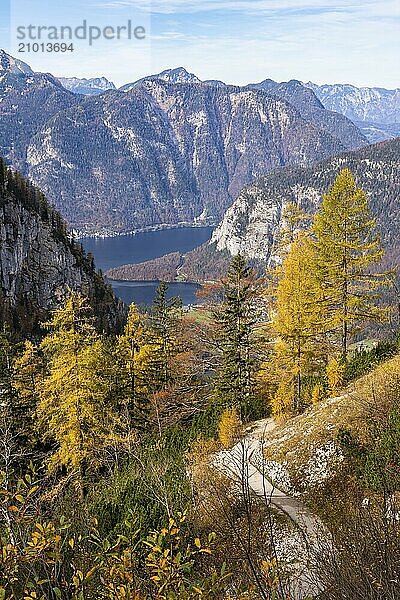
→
(313, 169, 387, 358)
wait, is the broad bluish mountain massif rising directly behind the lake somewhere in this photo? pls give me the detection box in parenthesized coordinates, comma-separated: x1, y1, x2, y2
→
(0, 54, 367, 233)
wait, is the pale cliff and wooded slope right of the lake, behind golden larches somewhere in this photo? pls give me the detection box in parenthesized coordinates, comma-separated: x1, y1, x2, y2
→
(180, 138, 400, 280)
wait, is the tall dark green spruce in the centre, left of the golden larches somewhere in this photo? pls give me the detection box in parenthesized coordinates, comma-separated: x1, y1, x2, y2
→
(214, 255, 258, 421)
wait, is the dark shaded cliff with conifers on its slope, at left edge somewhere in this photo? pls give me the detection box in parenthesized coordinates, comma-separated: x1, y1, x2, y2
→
(0, 162, 124, 334)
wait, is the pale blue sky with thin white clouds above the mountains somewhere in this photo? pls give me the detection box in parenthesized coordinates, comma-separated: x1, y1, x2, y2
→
(0, 0, 400, 88)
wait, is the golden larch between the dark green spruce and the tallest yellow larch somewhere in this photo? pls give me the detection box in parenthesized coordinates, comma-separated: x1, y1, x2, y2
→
(271, 232, 325, 412)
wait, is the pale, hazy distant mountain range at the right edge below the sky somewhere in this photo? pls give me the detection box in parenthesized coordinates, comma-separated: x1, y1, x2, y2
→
(305, 82, 400, 142)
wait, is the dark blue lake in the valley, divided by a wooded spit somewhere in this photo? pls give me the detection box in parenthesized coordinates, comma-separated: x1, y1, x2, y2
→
(80, 227, 213, 305)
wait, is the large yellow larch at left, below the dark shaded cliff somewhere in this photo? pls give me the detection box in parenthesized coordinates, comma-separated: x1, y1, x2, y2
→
(37, 293, 117, 495)
